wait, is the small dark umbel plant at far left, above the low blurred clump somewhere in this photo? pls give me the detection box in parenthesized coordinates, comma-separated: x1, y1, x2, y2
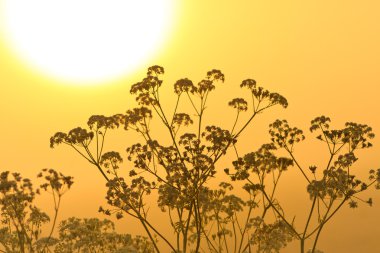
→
(0, 169, 73, 253)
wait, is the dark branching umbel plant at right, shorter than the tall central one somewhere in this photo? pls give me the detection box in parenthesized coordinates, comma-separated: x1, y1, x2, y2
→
(227, 116, 380, 253)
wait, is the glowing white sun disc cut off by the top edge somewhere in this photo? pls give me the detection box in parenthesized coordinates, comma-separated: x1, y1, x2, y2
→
(0, 0, 174, 84)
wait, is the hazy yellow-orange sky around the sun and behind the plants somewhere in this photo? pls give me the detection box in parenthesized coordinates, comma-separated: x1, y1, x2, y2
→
(0, 0, 380, 253)
